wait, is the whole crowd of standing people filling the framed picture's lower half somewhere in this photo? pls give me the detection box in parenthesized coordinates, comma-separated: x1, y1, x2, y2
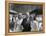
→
(10, 12, 42, 32)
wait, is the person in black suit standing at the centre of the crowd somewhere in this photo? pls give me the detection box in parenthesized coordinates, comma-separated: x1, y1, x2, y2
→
(21, 14, 31, 32)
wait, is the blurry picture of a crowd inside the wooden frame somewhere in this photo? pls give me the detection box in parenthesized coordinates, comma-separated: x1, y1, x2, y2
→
(9, 3, 43, 32)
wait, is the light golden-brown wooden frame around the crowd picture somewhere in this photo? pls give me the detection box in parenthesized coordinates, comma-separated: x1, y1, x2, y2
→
(5, 1, 45, 35)
